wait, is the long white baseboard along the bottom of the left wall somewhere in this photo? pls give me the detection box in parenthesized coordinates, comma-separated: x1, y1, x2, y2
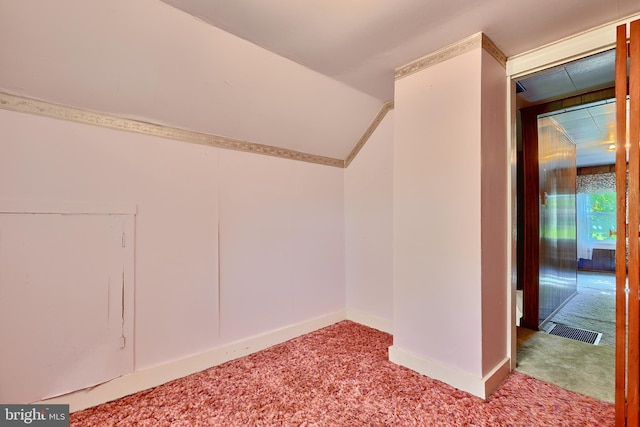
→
(35, 310, 347, 412)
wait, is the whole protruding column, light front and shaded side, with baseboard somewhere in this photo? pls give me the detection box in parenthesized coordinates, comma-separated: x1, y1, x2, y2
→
(389, 46, 509, 398)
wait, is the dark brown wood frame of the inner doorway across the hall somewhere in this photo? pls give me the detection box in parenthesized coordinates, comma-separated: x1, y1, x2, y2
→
(518, 87, 615, 331)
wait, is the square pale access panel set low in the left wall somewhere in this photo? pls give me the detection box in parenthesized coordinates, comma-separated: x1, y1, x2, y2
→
(0, 210, 134, 403)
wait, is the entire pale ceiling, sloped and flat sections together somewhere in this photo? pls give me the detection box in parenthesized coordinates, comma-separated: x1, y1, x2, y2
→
(0, 0, 640, 164)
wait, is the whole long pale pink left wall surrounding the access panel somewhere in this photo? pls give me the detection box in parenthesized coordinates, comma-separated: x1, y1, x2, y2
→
(0, 110, 345, 404)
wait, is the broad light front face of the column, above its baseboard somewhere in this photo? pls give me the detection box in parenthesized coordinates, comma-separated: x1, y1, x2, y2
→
(393, 49, 481, 376)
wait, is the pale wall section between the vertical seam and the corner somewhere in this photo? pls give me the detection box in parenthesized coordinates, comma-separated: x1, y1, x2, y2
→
(219, 150, 345, 342)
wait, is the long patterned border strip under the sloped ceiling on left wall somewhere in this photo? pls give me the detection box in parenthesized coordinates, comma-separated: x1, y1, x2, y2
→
(0, 93, 344, 168)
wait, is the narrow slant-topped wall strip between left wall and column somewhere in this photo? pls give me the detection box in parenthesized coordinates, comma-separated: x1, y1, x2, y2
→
(345, 111, 394, 332)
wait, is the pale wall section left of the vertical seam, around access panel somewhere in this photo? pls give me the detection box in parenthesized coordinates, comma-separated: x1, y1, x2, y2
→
(0, 111, 218, 369)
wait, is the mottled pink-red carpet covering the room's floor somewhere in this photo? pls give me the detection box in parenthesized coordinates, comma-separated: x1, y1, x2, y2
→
(71, 321, 614, 426)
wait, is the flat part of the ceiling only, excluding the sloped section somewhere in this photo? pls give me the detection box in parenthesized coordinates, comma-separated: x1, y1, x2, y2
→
(163, 0, 640, 101)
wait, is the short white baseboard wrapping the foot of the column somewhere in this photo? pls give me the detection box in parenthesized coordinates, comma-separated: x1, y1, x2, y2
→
(389, 346, 510, 399)
